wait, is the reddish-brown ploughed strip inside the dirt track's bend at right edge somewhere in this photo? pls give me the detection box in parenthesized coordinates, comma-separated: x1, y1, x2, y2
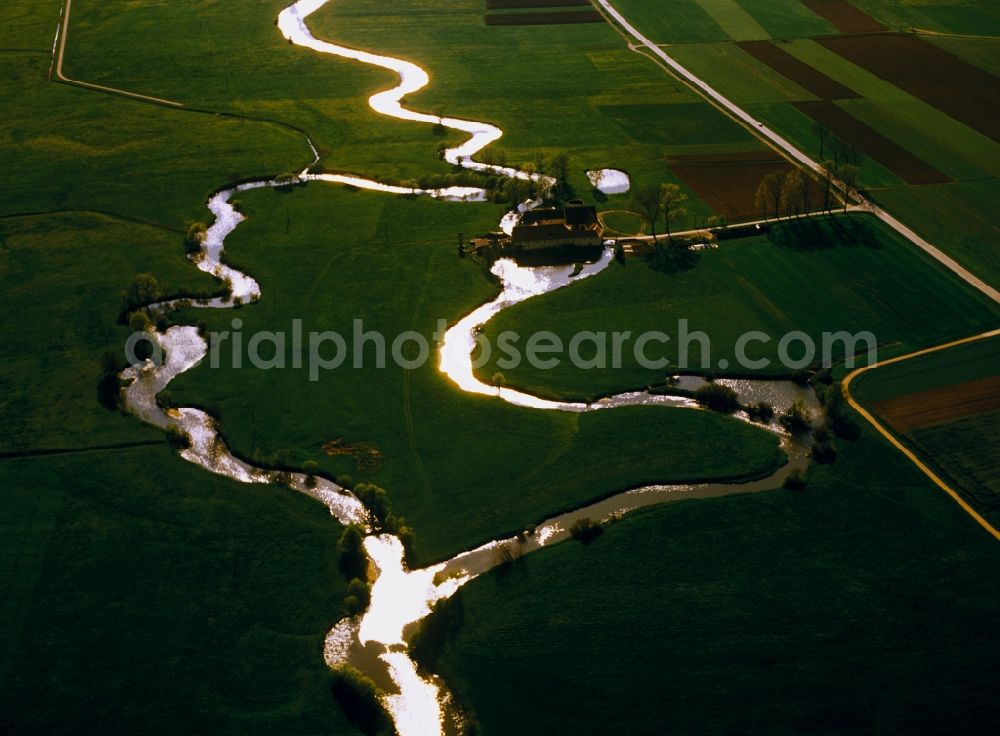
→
(872, 376, 1000, 434)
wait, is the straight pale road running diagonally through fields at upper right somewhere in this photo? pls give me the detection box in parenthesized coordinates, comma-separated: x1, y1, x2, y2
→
(596, 0, 1000, 303)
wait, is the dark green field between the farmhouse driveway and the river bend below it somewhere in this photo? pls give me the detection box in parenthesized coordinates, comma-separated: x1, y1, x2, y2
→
(480, 217, 1000, 397)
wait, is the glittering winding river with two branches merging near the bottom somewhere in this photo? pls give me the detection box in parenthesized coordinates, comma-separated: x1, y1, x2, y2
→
(121, 0, 818, 736)
